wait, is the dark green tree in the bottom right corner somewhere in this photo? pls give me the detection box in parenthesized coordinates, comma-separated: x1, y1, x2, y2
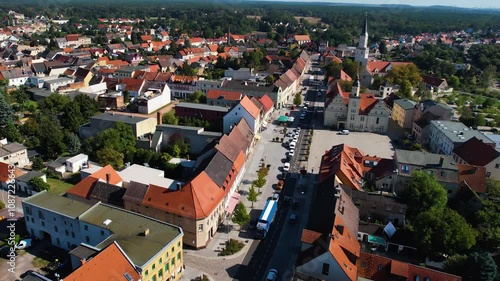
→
(464, 252, 497, 281)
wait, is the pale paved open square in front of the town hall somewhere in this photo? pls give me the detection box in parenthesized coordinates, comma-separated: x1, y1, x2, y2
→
(309, 129, 394, 171)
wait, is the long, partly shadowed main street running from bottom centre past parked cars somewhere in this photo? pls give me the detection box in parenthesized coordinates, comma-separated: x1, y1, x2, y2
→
(236, 58, 323, 281)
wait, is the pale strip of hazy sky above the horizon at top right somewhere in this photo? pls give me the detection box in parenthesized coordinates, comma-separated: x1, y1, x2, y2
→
(276, 0, 500, 9)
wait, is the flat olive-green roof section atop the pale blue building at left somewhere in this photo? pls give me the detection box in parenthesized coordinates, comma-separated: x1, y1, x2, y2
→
(23, 191, 92, 218)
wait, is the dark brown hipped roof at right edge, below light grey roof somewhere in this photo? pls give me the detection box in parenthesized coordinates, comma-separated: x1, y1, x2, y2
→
(453, 137, 500, 166)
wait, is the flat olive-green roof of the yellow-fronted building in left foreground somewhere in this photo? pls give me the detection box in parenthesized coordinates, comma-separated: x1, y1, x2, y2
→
(80, 203, 182, 266)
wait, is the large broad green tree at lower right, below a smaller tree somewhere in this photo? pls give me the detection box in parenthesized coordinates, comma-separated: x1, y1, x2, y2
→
(411, 207, 476, 255)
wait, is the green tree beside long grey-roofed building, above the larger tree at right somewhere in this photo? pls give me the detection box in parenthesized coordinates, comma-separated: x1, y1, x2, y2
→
(404, 171, 448, 214)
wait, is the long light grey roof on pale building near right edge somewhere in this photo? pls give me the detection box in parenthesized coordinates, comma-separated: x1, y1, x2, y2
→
(431, 120, 494, 143)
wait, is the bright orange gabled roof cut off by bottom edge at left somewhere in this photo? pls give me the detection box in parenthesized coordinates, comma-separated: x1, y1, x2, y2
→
(64, 242, 141, 281)
